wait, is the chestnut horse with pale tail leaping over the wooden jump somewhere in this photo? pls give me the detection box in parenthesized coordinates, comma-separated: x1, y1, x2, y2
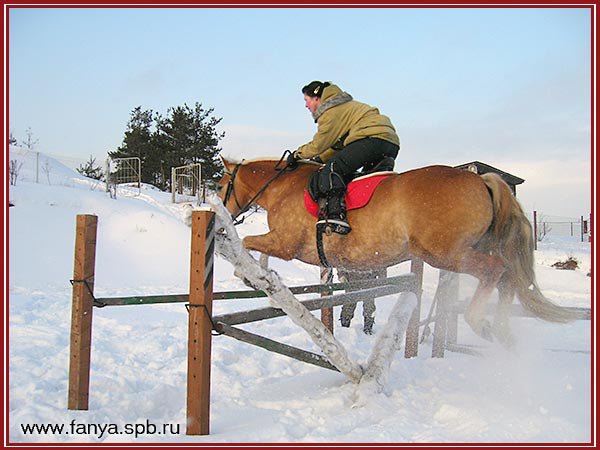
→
(219, 159, 577, 343)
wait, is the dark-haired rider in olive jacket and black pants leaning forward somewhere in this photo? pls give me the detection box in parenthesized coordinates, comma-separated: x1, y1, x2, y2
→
(288, 81, 400, 234)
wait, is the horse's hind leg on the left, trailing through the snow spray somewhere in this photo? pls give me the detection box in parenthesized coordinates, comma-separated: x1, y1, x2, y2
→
(457, 249, 505, 341)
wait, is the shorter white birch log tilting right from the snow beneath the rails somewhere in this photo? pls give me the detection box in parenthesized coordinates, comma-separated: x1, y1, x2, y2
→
(358, 292, 417, 395)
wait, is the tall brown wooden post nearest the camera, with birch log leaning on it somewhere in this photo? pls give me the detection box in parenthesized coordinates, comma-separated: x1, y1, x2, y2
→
(186, 211, 215, 435)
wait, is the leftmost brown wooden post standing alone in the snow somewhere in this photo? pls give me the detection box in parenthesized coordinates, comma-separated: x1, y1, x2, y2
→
(67, 214, 98, 410)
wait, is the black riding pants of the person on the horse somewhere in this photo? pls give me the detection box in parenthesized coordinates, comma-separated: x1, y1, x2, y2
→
(310, 137, 400, 198)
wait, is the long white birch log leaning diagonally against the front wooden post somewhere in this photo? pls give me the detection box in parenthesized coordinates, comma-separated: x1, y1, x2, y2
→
(208, 195, 363, 383)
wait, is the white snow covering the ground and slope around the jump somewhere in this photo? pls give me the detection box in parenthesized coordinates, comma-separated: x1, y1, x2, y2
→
(7, 152, 593, 444)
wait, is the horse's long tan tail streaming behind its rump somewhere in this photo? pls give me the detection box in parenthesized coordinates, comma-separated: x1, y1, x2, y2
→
(481, 173, 579, 323)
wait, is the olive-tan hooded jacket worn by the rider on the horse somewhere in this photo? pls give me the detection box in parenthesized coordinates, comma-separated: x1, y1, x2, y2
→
(295, 84, 400, 162)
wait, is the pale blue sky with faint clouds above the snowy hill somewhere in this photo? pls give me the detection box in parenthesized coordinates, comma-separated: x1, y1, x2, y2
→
(5, 7, 593, 217)
